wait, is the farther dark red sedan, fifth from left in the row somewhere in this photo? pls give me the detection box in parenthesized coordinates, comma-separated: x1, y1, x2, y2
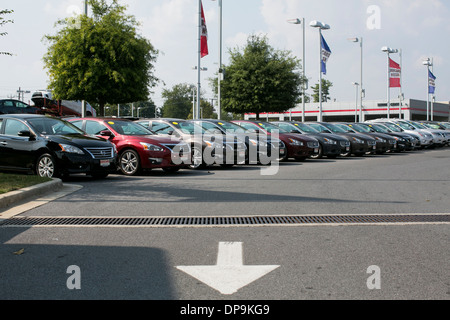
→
(231, 120, 319, 161)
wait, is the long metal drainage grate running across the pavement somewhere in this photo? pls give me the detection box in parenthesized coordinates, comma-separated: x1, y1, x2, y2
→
(0, 214, 450, 227)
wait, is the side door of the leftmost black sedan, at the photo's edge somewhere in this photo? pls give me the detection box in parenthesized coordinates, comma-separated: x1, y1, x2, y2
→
(0, 119, 37, 169)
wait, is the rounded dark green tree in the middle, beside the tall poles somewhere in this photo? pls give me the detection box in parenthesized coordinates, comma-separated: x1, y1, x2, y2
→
(218, 35, 302, 117)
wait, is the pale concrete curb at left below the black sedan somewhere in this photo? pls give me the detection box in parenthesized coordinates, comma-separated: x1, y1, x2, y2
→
(0, 179, 63, 209)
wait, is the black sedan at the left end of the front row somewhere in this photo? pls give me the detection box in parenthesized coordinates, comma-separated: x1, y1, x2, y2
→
(0, 114, 117, 178)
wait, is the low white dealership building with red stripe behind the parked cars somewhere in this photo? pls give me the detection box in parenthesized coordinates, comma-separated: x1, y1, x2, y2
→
(245, 99, 450, 122)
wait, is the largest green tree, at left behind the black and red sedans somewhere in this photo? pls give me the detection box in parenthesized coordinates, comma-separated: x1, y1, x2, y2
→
(44, 0, 158, 115)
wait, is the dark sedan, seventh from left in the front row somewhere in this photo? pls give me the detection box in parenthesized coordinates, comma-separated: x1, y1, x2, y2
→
(306, 122, 376, 157)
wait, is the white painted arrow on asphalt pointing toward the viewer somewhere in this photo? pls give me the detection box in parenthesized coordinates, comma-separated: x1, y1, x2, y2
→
(176, 242, 279, 295)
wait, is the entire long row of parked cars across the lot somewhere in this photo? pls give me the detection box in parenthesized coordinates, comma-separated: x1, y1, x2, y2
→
(0, 114, 450, 178)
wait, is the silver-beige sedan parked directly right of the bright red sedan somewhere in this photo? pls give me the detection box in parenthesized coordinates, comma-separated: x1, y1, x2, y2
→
(135, 118, 247, 169)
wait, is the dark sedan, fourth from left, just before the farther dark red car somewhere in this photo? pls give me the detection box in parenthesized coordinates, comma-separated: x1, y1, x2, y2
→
(187, 119, 287, 164)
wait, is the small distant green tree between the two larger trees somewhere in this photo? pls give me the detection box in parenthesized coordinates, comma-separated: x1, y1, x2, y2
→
(161, 83, 193, 119)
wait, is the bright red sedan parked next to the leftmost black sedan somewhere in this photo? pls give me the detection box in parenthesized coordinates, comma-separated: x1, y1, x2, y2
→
(67, 118, 191, 175)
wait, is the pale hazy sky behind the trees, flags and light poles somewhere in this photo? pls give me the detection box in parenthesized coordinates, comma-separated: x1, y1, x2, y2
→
(0, 0, 450, 107)
